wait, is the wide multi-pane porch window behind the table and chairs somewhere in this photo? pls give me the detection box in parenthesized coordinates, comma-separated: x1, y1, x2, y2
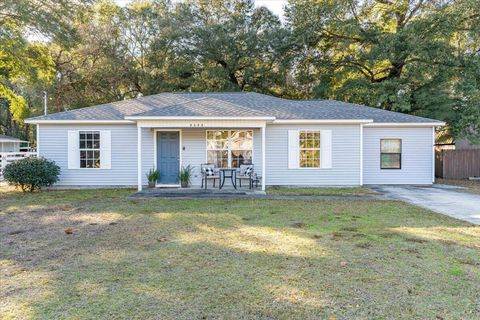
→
(207, 130, 253, 168)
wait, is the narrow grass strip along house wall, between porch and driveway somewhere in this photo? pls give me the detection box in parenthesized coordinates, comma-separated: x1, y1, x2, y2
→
(267, 186, 379, 196)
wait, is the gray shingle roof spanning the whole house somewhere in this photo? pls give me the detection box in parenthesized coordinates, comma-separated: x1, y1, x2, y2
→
(25, 92, 440, 123)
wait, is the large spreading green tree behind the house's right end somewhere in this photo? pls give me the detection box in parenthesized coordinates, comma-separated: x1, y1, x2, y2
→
(286, 0, 480, 141)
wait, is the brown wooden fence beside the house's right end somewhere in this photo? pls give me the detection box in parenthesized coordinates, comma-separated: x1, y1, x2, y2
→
(435, 150, 480, 179)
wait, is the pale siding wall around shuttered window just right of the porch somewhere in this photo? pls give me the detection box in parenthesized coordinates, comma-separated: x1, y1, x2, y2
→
(266, 124, 360, 186)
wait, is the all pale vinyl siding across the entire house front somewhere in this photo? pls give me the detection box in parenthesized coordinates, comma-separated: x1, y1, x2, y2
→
(39, 124, 433, 186)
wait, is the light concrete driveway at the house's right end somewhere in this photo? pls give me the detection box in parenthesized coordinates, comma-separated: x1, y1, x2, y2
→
(372, 185, 480, 225)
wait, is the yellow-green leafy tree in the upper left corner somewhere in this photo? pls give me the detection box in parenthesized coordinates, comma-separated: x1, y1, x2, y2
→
(0, 0, 86, 139)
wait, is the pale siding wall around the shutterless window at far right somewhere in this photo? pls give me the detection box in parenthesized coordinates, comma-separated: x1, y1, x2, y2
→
(363, 127, 433, 184)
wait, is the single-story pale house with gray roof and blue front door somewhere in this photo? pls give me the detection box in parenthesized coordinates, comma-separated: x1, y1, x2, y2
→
(26, 92, 444, 190)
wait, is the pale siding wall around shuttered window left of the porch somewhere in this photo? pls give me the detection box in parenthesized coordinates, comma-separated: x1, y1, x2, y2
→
(39, 124, 137, 186)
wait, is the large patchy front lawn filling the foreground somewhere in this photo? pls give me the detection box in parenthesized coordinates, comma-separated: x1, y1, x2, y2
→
(0, 186, 480, 319)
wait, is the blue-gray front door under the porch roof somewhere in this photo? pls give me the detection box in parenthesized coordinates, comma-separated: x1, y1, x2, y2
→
(157, 131, 180, 184)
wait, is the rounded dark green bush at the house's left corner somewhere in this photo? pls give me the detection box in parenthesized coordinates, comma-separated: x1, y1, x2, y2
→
(3, 157, 60, 192)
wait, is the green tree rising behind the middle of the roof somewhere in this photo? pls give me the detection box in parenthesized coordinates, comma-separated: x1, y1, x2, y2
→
(177, 0, 288, 94)
